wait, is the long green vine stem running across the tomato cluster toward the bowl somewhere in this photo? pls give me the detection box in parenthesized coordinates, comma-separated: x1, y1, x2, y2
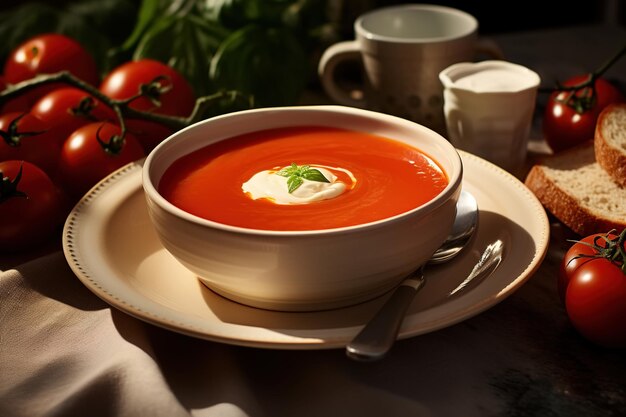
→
(0, 71, 253, 136)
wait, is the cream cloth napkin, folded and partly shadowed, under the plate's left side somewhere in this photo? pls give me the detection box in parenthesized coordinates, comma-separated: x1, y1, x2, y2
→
(0, 253, 258, 417)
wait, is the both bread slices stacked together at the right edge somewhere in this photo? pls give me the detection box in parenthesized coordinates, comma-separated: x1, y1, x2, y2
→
(525, 104, 626, 236)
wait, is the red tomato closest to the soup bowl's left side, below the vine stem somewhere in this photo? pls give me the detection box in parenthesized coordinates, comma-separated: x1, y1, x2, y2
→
(59, 122, 145, 197)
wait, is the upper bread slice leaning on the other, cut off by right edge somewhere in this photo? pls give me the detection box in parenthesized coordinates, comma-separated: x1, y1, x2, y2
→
(594, 104, 626, 187)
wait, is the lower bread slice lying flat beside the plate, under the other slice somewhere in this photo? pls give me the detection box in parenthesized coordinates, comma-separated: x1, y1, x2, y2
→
(525, 140, 626, 236)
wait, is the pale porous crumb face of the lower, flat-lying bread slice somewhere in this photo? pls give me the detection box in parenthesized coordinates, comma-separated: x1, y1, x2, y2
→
(543, 147, 626, 223)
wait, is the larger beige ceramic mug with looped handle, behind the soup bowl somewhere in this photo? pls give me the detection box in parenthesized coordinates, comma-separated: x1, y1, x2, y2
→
(318, 4, 502, 134)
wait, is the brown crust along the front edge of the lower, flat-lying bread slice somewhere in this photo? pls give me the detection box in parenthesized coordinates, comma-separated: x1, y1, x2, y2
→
(524, 165, 626, 236)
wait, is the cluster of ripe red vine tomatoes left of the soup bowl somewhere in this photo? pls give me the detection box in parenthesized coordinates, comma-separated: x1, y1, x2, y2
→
(0, 33, 195, 250)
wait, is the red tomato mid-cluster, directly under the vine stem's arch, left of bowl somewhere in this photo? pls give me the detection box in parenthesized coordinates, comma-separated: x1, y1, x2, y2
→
(30, 87, 117, 142)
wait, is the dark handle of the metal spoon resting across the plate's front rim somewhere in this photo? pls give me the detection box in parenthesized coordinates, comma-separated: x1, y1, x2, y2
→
(346, 268, 424, 361)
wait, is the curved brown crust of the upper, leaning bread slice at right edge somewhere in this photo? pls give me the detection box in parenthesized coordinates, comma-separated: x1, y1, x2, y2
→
(593, 104, 626, 187)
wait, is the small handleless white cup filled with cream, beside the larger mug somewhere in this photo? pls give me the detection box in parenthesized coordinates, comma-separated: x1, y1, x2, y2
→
(439, 61, 541, 174)
